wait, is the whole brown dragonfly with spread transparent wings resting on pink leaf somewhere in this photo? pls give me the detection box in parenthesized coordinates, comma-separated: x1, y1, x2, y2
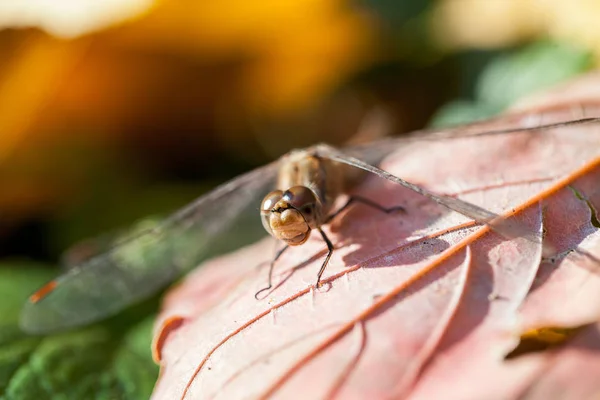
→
(20, 118, 600, 334)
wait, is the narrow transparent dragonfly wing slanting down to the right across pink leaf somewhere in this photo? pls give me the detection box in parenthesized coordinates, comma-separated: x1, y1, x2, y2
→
(316, 145, 542, 243)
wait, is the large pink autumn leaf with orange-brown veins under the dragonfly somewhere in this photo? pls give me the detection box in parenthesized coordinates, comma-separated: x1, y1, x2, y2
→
(153, 78, 600, 399)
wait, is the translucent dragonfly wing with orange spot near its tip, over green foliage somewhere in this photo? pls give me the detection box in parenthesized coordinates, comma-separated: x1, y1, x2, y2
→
(21, 162, 278, 333)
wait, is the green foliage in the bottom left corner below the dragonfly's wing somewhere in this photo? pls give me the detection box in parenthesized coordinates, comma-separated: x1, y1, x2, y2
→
(0, 264, 158, 400)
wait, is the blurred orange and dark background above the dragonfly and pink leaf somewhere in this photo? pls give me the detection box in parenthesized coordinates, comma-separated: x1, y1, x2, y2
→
(0, 0, 600, 263)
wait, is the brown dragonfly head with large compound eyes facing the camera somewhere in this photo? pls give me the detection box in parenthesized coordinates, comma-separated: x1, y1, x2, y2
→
(260, 186, 320, 246)
